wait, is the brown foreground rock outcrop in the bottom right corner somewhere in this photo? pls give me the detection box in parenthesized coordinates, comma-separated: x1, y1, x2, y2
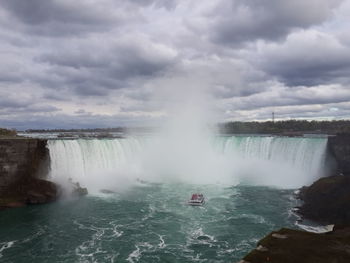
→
(240, 228, 350, 263)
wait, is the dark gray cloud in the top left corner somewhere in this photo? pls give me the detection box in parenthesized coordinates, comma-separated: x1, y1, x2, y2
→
(0, 0, 148, 37)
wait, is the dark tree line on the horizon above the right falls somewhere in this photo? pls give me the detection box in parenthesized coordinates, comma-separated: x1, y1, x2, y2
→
(219, 120, 350, 135)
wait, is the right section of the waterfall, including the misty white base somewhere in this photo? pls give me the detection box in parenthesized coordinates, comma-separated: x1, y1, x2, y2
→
(215, 136, 327, 188)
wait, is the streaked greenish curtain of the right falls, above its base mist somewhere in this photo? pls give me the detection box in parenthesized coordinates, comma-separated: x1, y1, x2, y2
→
(215, 136, 328, 182)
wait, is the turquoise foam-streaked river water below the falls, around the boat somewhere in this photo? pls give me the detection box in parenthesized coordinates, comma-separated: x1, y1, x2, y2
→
(0, 184, 296, 262)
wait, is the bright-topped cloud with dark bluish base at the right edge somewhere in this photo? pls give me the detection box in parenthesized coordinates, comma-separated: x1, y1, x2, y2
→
(251, 31, 350, 86)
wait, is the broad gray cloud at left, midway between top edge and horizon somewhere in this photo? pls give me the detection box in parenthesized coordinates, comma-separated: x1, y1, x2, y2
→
(36, 35, 177, 96)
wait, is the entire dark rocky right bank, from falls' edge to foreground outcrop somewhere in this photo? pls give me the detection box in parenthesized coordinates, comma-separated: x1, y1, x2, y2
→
(240, 134, 350, 263)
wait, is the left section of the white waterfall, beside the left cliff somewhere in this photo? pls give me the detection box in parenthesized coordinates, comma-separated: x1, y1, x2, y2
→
(48, 138, 143, 192)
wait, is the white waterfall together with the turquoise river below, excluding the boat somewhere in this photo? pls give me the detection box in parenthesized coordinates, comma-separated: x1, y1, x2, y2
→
(0, 136, 327, 262)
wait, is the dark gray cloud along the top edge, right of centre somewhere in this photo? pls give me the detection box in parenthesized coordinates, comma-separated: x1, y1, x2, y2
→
(210, 0, 341, 45)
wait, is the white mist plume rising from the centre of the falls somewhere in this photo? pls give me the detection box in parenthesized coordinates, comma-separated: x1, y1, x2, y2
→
(138, 81, 234, 184)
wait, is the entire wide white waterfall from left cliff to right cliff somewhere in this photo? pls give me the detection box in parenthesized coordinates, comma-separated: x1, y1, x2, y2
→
(48, 136, 327, 188)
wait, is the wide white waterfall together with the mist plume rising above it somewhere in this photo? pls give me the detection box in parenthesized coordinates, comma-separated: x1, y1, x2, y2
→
(49, 80, 326, 192)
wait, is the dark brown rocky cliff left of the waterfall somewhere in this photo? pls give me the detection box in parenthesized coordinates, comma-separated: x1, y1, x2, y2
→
(0, 137, 58, 209)
